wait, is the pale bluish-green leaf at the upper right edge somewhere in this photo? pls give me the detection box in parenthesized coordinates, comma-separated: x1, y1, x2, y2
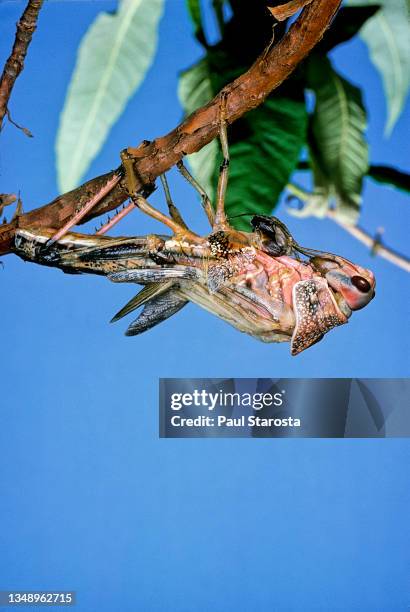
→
(349, 0, 410, 135)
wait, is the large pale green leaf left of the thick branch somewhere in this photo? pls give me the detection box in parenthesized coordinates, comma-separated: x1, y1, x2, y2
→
(56, 0, 164, 192)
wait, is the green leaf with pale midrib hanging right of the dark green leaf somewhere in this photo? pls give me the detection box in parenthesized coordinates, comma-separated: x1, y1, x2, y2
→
(308, 56, 368, 223)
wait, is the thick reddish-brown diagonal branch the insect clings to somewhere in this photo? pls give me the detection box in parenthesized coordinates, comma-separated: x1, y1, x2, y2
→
(0, 0, 340, 254)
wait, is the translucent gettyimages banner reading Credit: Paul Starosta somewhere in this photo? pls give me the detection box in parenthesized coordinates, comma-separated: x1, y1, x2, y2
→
(159, 378, 410, 438)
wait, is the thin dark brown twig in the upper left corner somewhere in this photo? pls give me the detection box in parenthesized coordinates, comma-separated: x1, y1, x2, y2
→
(0, 0, 44, 131)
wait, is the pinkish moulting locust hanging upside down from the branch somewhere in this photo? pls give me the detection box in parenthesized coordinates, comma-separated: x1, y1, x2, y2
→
(15, 95, 375, 355)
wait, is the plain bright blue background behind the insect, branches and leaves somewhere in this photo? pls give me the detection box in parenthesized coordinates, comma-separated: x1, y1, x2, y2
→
(0, 0, 410, 612)
